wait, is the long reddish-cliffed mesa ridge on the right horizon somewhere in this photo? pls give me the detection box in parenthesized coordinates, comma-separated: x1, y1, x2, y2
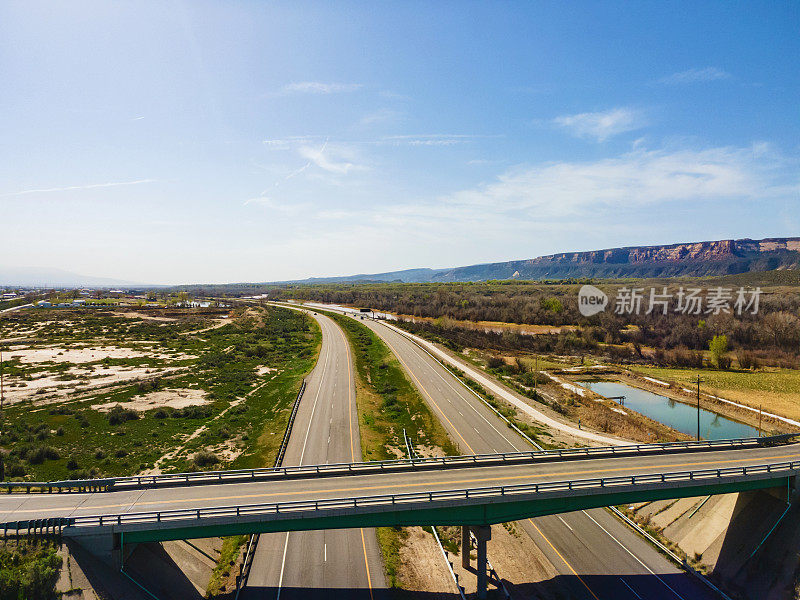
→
(282, 237, 800, 283)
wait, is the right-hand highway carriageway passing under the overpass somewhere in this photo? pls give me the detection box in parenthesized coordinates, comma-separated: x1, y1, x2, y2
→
(354, 320, 716, 600)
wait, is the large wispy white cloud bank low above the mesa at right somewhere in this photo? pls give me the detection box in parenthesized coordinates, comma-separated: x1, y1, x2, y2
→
(444, 147, 798, 218)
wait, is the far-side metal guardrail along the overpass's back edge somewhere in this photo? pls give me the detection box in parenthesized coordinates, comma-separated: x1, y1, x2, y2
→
(0, 433, 800, 493)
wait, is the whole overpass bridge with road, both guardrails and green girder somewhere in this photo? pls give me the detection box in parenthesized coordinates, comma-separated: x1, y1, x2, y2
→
(6, 436, 800, 552)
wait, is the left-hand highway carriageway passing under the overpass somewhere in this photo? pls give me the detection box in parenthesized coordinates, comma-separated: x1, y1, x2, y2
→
(241, 315, 386, 600)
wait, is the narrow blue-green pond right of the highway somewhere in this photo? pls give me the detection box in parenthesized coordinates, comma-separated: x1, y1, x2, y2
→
(580, 381, 758, 440)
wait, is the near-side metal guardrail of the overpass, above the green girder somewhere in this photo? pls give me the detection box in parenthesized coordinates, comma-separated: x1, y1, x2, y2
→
(7, 461, 800, 533)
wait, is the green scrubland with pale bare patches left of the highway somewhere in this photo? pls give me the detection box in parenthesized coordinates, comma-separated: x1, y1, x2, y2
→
(0, 308, 320, 480)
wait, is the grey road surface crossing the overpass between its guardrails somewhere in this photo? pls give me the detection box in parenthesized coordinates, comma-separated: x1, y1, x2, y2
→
(0, 446, 800, 524)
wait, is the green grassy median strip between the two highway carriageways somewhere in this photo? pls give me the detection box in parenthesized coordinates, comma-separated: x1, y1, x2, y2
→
(320, 311, 459, 588)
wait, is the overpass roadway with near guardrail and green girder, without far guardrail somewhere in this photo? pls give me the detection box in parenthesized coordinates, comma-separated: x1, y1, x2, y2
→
(0, 444, 800, 541)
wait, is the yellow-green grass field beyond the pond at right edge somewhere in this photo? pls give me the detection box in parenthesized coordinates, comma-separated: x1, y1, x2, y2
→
(628, 365, 800, 420)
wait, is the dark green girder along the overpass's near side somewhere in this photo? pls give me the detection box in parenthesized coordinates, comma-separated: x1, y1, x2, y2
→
(115, 474, 794, 544)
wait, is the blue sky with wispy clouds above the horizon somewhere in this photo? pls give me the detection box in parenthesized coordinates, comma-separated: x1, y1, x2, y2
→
(0, 1, 800, 283)
